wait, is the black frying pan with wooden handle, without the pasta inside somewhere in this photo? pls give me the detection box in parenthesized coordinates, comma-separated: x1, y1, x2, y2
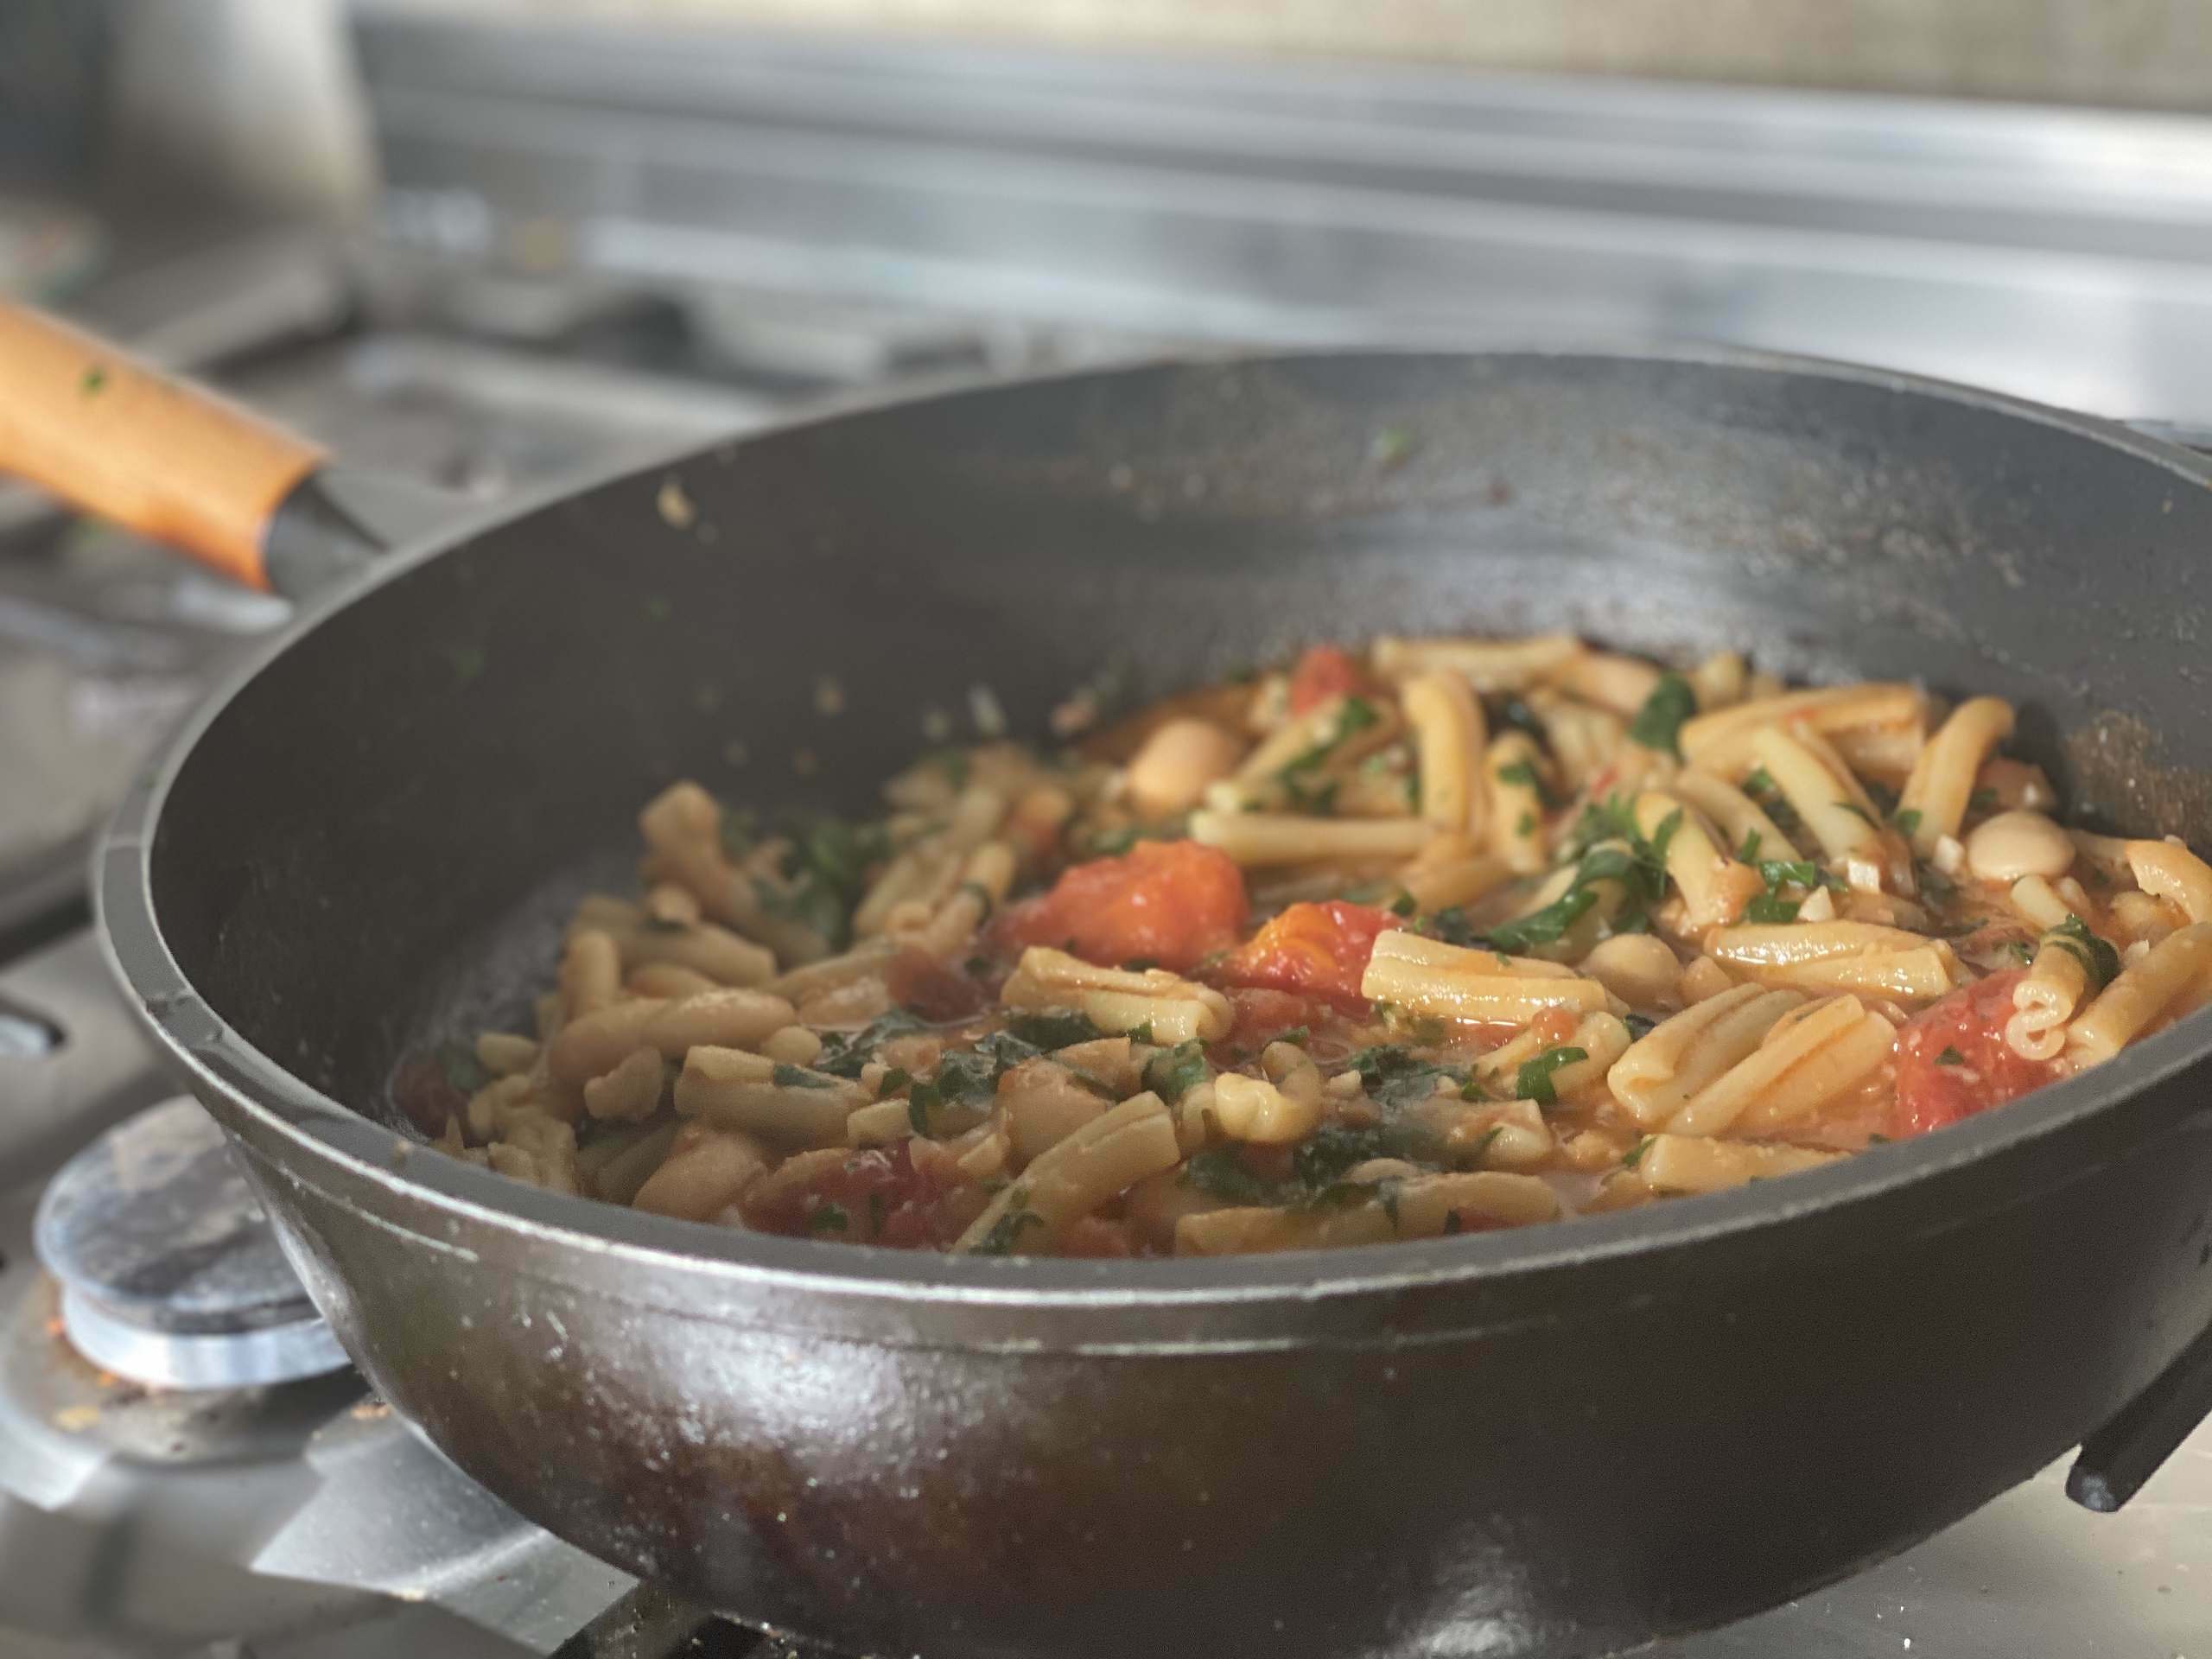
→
(0, 302, 2212, 1659)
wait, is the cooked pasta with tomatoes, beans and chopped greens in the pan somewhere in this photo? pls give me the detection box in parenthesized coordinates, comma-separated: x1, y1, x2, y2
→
(396, 635, 2212, 1256)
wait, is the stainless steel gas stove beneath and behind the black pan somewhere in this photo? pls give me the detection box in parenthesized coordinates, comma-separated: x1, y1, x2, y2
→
(13, 17, 2212, 1659)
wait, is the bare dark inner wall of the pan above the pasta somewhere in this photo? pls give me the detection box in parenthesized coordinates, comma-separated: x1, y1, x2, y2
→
(138, 354, 2212, 1167)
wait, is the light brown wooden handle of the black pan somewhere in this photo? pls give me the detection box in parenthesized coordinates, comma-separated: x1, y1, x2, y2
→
(0, 301, 323, 588)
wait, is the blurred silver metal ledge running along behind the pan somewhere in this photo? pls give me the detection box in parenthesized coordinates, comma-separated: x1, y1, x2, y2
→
(359, 7, 2212, 416)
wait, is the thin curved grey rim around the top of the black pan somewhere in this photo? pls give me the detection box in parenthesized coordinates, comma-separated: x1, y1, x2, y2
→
(93, 343, 2212, 1314)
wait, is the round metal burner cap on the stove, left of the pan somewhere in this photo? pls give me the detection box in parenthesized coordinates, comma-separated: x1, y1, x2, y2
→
(35, 1097, 347, 1389)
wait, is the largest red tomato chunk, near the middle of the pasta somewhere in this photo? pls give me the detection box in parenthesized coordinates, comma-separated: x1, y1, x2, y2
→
(993, 841, 1248, 971)
